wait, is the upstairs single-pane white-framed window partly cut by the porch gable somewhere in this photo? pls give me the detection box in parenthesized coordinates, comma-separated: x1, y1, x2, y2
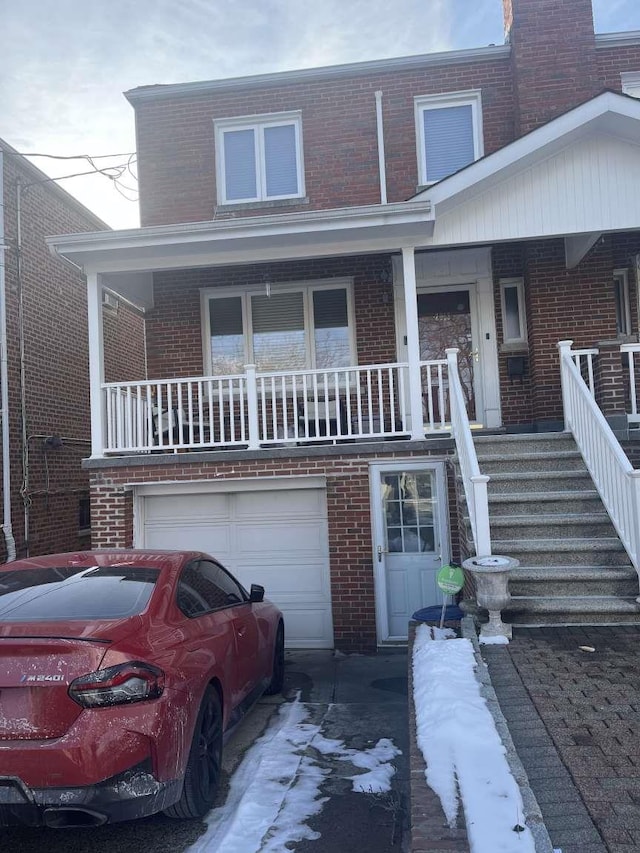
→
(415, 91, 484, 185)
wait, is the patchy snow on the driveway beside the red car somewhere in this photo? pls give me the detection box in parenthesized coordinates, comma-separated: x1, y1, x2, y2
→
(188, 700, 400, 853)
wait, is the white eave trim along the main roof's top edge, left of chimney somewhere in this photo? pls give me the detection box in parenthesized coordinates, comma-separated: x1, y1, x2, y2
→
(124, 44, 511, 106)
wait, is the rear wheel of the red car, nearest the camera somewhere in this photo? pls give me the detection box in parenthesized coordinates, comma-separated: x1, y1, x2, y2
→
(165, 686, 222, 820)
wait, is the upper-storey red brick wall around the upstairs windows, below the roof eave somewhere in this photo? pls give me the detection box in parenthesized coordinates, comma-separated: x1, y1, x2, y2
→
(136, 58, 513, 225)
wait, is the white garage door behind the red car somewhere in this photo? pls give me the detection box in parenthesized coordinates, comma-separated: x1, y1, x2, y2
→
(138, 488, 333, 648)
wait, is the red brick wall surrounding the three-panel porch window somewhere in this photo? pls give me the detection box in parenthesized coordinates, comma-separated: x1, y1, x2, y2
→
(147, 255, 396, 379)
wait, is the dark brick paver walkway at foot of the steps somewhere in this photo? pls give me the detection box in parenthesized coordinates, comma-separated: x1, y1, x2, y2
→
(483, 626, 640, 853)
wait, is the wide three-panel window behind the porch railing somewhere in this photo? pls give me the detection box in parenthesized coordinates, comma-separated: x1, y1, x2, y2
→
(203, 280, 355, 376)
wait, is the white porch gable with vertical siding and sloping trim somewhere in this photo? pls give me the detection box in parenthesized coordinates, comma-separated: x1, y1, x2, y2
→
(416, 92, 640, 248)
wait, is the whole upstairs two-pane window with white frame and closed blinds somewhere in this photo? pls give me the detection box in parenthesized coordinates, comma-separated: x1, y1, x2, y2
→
(215, 113, 304, 204)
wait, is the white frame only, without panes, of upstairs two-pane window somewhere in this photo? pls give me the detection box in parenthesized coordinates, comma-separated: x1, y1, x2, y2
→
(213, 110, 305, 205)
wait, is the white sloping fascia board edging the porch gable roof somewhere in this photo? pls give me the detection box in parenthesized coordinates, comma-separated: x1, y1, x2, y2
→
(414, 92, 640, 216)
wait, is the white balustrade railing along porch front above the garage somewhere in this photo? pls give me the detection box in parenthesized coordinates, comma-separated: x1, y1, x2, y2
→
(102, 360, 449, 453)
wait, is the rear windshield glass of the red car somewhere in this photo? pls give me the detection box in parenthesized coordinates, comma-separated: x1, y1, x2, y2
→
(0, 566, 160, 623)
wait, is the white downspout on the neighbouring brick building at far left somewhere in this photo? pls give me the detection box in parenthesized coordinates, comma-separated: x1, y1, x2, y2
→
(0, 151, 16, 563)
